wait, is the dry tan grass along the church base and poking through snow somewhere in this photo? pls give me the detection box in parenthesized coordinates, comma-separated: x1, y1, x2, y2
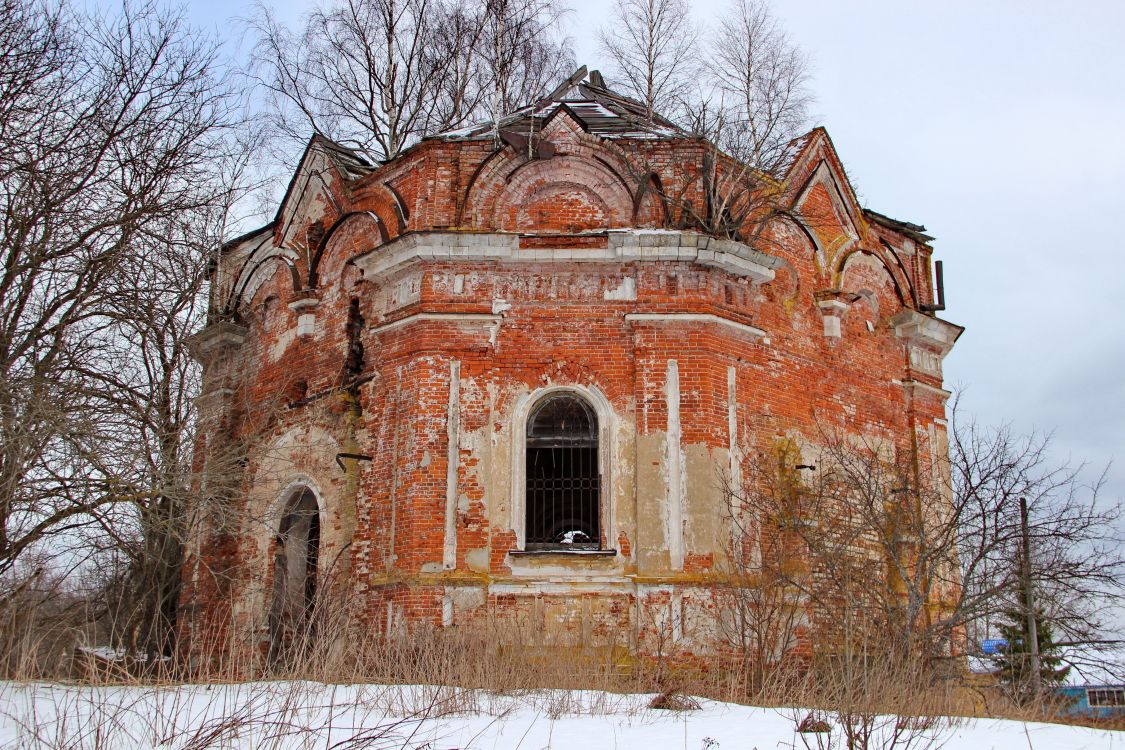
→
(0, 584, 1107, 750)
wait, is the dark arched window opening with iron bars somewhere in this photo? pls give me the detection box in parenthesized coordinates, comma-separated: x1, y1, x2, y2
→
(524, 394, 602, 550)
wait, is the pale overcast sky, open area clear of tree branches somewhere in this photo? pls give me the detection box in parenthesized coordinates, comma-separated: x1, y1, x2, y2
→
(189, 0, 1125, 497)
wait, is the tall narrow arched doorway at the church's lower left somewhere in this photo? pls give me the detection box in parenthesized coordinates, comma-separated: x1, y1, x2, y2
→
(263, 488, 321, 661)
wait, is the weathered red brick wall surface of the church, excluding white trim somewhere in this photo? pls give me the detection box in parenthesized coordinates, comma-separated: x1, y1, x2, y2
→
(186, 124, 958, 670)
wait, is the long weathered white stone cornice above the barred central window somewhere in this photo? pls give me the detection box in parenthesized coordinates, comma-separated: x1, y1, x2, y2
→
(352, 229, 782, 282)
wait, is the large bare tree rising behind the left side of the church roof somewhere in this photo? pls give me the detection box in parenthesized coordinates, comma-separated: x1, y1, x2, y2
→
(251, 0, 475, 161)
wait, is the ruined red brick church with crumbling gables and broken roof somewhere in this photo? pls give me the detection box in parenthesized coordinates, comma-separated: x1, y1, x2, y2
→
(183, 68, 962, 652)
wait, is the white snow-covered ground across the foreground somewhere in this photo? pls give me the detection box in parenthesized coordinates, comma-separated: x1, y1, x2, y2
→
(0, 683, 1125, 750)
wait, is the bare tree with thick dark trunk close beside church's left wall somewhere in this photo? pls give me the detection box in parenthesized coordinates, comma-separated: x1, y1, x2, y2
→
(86, 208, 237, 663)
